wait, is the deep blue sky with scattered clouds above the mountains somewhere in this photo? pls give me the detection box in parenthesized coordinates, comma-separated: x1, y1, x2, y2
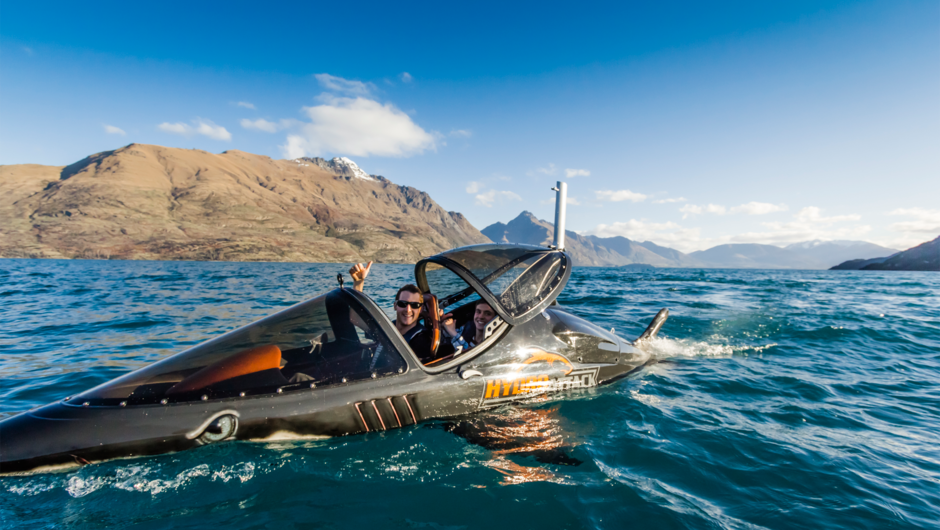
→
(0, 1, 940, 250)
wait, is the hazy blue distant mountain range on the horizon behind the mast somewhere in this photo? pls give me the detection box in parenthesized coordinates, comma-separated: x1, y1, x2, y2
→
(481, 212, 897, 269)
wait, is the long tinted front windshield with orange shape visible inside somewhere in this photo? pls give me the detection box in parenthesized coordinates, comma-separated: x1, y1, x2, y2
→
(76, 291, 406, 405)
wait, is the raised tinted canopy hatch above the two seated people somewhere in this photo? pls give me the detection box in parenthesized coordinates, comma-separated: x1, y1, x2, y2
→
(415, 244, 571, 325)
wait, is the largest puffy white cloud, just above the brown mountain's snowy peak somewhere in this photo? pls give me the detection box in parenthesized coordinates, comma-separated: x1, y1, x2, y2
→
(281, 94, 440, 158)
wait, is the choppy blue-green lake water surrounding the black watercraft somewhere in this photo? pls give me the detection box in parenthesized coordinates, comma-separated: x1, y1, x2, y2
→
(0, 260, 940, 529)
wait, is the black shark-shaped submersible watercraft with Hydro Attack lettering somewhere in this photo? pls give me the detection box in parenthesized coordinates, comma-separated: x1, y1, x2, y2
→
(0, 183, 668, 473)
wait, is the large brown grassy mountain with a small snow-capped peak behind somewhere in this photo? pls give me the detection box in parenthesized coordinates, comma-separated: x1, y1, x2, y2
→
(0, 144, 488, 263)
